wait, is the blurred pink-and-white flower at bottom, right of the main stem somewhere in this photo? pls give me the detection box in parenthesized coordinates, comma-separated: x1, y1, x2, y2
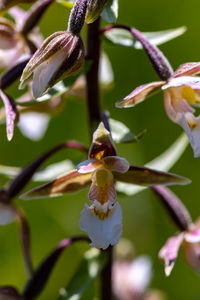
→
(112, 238, 153, 300)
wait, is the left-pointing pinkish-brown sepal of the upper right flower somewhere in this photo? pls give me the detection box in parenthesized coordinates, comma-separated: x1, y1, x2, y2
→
(116, 81, 165, 108)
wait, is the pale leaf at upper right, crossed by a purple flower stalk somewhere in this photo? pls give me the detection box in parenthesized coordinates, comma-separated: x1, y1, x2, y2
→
(104, 26, 187, 49)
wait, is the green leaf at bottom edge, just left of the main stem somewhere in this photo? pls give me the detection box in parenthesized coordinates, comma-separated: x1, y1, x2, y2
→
(58, 248, 107, 300)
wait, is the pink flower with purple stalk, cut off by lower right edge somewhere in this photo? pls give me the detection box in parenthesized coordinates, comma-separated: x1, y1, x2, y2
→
(152, 186, 200, 276)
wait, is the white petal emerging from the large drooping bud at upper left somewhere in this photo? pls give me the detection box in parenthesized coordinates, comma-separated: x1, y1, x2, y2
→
(32, 48, 66, 98)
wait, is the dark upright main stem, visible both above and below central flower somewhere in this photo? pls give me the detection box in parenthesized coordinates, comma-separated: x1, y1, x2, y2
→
(86, 17, 113, 300)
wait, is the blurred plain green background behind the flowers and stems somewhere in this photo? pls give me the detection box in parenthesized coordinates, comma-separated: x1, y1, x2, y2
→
(0, 0, 200, 300)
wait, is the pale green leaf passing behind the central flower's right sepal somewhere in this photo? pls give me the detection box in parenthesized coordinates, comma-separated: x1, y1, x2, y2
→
(116, 133, 189, 196)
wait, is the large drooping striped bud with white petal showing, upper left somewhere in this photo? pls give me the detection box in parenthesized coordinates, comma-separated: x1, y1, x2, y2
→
(19, 31, 84, 98)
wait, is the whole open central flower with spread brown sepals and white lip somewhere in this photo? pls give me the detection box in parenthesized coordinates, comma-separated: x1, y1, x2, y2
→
(21, 123, 189, 249)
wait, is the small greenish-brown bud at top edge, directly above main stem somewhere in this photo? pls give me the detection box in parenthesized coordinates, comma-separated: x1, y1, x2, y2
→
(86, 0, 108, 24)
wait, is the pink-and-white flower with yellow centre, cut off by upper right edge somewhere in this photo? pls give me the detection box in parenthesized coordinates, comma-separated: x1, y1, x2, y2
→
(117, 62, 200, 157)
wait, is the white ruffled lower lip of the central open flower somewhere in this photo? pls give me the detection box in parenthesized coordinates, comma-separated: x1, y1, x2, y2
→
(79, 201, 122, 250)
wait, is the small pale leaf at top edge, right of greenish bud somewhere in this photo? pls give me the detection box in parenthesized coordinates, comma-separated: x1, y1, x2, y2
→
(101, 0, 119, 23)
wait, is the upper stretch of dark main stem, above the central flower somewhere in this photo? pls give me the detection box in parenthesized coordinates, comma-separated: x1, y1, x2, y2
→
(86, 18, 102, 136)
